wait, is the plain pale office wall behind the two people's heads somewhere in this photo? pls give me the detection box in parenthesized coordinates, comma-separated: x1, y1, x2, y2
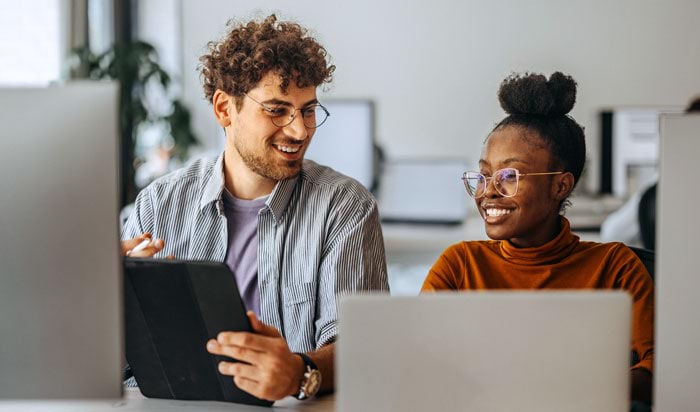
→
(181, 0, 700, 192)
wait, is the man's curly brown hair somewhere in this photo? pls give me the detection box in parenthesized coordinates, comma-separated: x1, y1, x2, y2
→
(199, 14, 335, 110)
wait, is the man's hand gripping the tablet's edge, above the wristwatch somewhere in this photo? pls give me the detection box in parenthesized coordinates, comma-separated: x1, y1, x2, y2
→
(207, 312, 305, 401)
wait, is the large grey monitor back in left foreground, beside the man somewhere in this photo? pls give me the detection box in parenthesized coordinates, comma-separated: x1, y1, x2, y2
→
(0, 82, 123, 398)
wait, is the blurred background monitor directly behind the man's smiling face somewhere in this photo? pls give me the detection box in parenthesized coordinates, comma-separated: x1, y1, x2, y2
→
(305, 99, 377, 190)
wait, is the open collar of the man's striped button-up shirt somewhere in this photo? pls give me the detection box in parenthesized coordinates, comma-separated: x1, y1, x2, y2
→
(199, 153, 303, 223)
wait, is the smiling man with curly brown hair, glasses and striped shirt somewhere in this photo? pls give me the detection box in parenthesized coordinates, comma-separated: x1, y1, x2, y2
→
(122, 15, 388, 400)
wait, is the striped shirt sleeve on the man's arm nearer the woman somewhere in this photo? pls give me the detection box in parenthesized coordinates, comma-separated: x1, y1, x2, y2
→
(315, 196, 389, 349)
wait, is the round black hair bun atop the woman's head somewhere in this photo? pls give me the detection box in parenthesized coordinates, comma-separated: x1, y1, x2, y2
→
(498, 72, 576, 116)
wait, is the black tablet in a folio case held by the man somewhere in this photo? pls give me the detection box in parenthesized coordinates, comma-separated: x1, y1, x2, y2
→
(124, 258, 272, 406)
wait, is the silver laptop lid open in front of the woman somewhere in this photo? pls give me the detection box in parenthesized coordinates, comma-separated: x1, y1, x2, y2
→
(337, 291, 631, 412)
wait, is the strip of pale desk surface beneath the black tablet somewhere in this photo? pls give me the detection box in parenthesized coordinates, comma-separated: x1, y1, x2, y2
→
(0, 388, 335, 412)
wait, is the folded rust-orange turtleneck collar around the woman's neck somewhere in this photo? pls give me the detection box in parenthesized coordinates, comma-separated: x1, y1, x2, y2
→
(500, 216, 579, 265)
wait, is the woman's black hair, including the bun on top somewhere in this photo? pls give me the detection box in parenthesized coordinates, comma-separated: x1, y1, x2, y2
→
(493, 72, 586, 195)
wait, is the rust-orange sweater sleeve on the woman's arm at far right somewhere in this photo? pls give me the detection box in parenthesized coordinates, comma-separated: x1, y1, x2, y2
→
(615, 244, 654, 372)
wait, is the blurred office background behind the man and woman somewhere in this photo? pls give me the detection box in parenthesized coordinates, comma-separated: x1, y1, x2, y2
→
(0, 0, 700, 293)
